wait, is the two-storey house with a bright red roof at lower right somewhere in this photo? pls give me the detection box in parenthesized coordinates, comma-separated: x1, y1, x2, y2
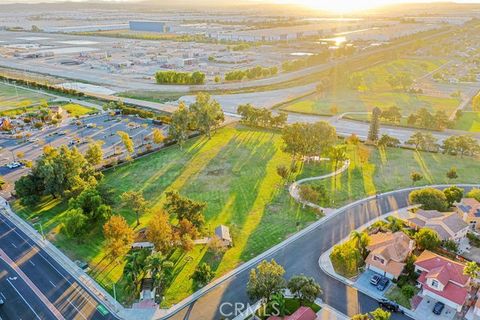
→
(415, 250, 470, 312)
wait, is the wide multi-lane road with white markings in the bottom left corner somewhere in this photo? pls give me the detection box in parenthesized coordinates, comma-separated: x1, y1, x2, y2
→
(0, 210, 116, 320)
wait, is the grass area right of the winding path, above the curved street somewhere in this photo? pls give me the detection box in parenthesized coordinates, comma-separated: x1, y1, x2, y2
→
(311, 146, 480, 207)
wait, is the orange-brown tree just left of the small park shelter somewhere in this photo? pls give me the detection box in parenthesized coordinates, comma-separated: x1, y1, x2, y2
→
(147, 211, 174, 254)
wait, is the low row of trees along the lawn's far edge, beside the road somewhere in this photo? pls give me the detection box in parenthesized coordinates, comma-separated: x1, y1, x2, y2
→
(237, 103, 287, 129)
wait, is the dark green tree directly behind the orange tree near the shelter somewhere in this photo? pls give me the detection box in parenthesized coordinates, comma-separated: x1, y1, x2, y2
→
(164, 191, 207, 230)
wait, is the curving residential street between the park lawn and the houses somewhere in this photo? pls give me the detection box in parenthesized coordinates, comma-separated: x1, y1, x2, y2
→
(164, 188, 476, 320)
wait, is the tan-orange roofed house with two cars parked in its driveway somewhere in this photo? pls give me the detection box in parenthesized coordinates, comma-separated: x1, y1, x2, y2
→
(365, 231, 415, 279)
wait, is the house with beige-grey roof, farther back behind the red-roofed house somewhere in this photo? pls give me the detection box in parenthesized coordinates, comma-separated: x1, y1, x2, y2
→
(406, 209, 468, 243)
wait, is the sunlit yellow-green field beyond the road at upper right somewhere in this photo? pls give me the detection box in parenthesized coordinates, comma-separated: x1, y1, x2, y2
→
(281, 59, 459, 115)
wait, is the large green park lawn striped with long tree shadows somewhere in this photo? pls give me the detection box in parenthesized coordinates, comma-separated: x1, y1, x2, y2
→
(15, 127, 322, 305)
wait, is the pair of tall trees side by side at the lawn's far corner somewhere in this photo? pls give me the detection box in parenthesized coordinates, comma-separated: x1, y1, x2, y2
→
(169, 93, 225, 146)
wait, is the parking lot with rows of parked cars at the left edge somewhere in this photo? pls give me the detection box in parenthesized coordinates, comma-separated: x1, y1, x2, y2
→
(0, 113, 167, 189)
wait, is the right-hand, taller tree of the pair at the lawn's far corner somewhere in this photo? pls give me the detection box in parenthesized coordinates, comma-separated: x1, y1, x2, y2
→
(189, 93, 225, 139)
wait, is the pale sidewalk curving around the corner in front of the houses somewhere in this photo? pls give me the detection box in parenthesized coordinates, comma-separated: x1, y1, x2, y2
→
(318, 205, 418, 319)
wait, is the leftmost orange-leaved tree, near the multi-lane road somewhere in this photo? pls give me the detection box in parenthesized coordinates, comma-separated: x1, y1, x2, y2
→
(103, 215, 135, 261)
